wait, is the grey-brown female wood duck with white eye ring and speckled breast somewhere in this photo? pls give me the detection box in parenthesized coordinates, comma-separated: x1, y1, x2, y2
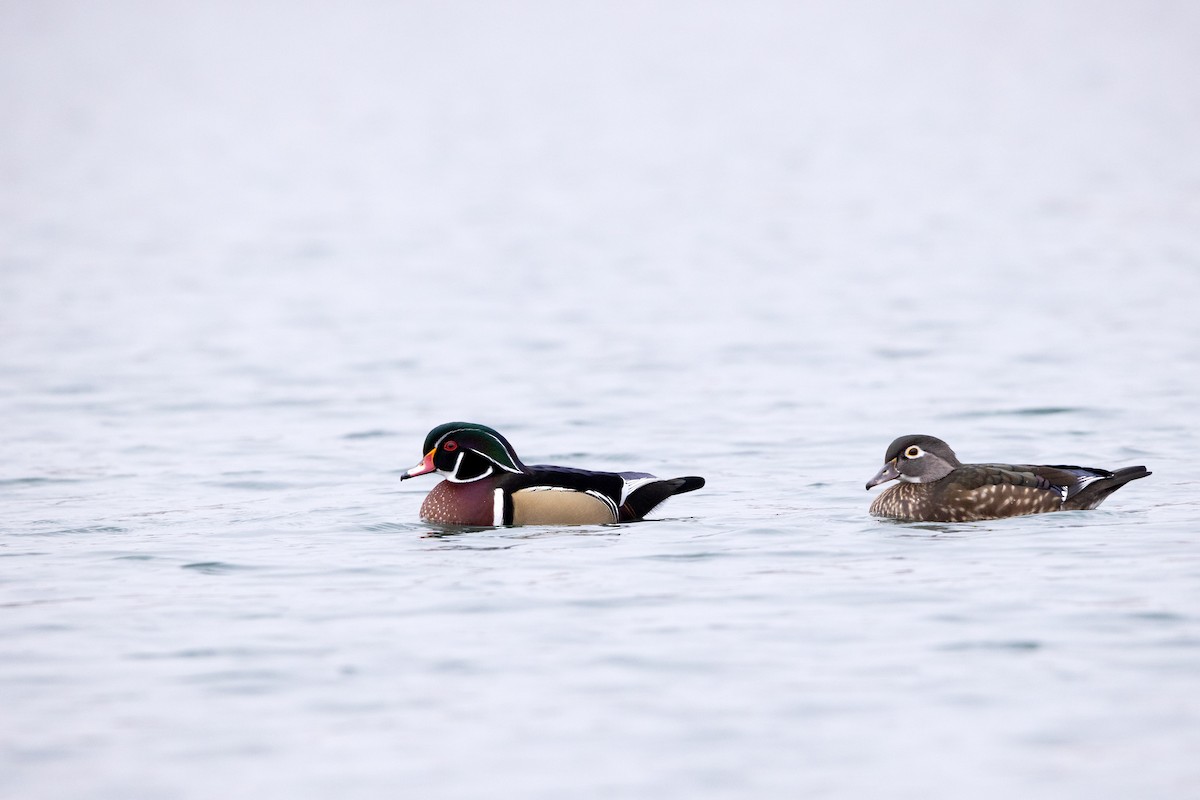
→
(866, 435, 1151, 522)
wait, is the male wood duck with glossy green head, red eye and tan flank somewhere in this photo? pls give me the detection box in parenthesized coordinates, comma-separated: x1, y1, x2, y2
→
(400, 422, 704, 525)
